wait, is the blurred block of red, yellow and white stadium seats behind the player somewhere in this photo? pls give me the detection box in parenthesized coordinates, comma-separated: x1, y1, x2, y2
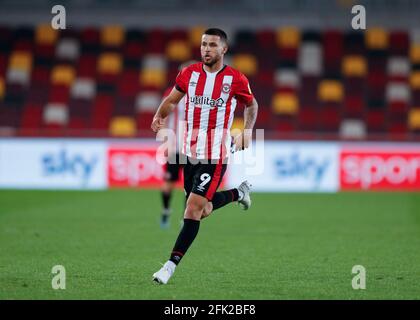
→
(0, 25, 420, 139)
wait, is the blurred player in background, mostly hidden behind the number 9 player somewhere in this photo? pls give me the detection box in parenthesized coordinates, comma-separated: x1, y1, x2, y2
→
(160, 60, 197, 229)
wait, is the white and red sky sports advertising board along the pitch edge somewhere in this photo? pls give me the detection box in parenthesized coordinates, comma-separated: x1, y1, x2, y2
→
(0, 138, 420, 192)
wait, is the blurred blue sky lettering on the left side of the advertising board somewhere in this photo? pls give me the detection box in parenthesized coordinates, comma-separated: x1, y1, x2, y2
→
(41, 149, 99, 185)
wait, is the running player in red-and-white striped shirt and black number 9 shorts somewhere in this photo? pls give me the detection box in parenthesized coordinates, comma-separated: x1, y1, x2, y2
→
(151, 28, 258, 284)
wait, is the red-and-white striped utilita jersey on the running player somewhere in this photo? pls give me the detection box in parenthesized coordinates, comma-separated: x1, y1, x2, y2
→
(175, 62, 253, 159)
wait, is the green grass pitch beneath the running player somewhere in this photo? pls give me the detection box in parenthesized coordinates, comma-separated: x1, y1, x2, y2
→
(0, 190, 420, 300)
